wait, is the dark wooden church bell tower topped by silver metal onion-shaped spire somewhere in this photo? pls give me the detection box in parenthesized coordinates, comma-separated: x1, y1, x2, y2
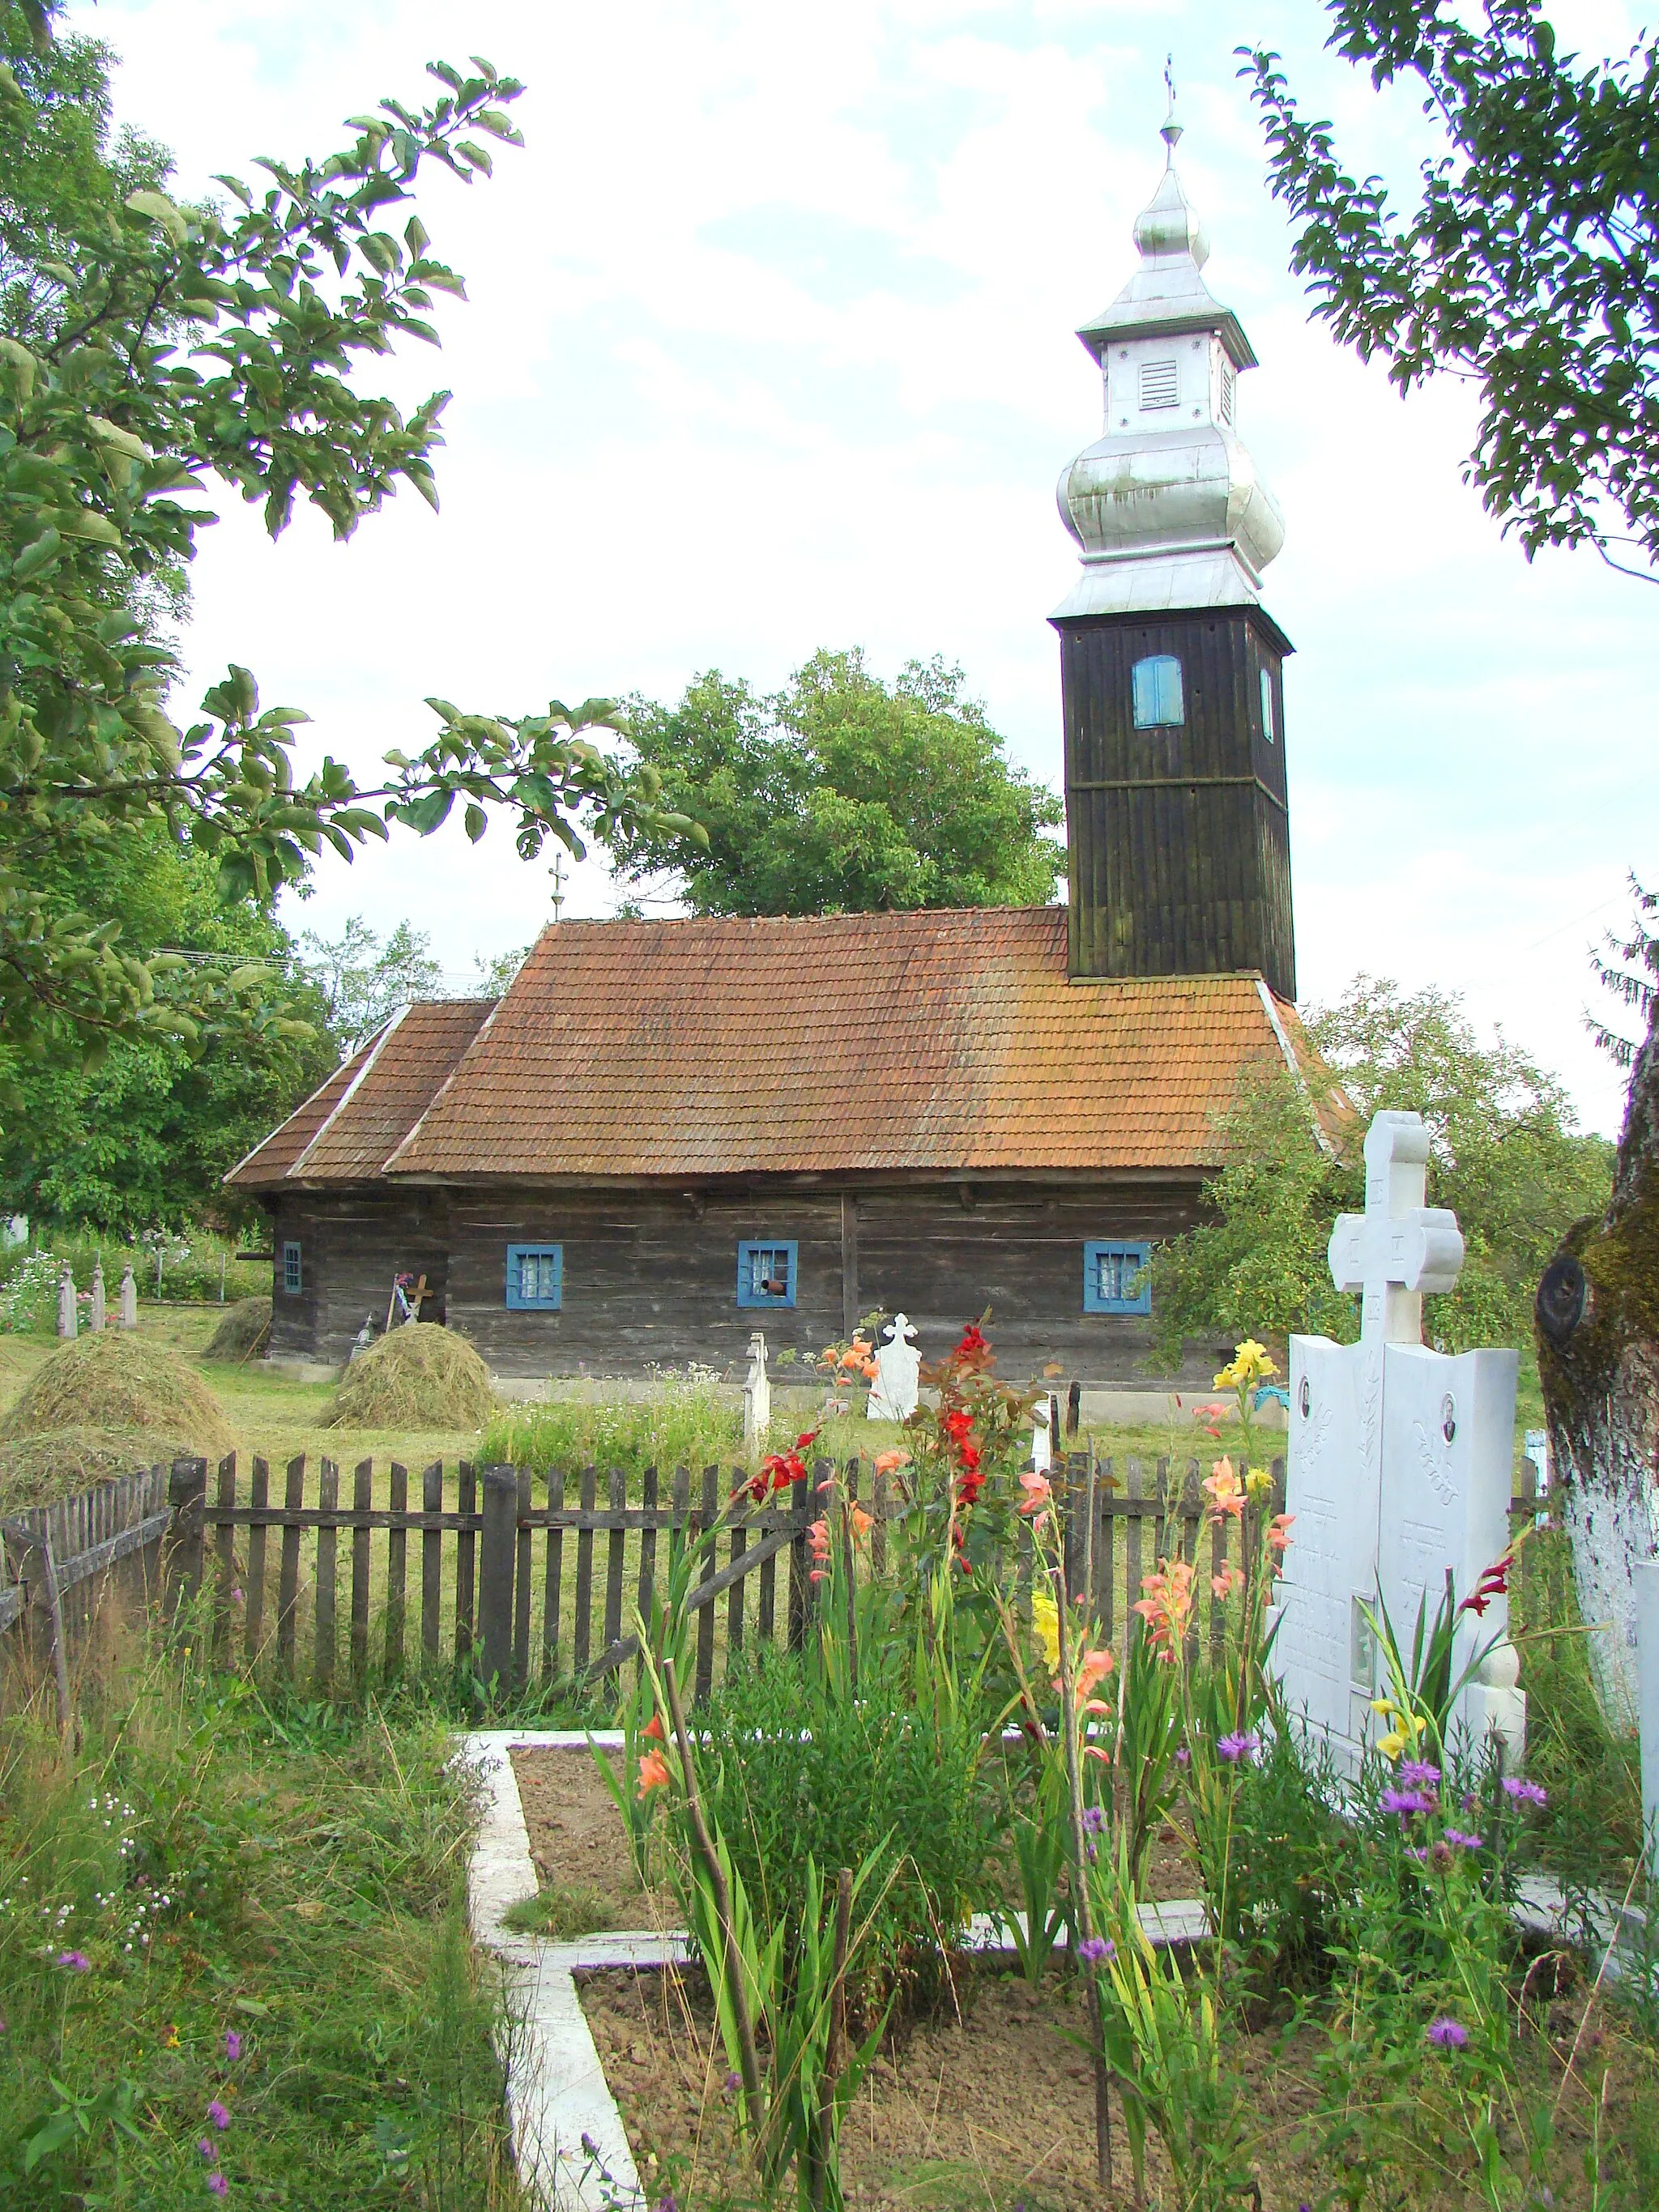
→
(1051, 102, 1296, 999)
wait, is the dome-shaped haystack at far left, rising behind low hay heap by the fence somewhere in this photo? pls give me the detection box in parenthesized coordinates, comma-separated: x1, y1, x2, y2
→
(0, 1329, 237, 1460)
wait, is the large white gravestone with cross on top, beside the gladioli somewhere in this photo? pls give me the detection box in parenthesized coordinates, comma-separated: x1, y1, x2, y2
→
(1274, 1113, 1526, 1767)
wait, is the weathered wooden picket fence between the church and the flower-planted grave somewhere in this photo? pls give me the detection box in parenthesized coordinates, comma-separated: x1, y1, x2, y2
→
(0, 1453, 1548, 1707)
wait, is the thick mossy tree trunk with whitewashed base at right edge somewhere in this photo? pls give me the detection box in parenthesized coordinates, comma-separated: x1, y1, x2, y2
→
(1537, 1007, 1659, 1728)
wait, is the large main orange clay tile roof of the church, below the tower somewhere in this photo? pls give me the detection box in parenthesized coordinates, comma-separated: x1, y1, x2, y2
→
(385, 907, 1301, 1181)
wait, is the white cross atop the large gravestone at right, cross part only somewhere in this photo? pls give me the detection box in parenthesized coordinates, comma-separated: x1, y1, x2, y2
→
(1327, 1113, 1462, 1345)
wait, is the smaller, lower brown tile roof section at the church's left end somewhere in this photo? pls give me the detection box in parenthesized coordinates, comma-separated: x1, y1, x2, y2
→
(226, 998, 496, 1190)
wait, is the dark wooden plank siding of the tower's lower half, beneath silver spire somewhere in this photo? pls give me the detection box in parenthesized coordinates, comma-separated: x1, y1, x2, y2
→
(1056, 606, 1296, 999)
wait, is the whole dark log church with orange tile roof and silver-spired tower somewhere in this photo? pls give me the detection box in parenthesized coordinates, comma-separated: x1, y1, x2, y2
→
(228, 121, 1336, 1385)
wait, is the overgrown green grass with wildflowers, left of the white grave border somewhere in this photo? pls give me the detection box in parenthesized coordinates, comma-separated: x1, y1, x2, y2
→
(0, 1641, 520, 2212)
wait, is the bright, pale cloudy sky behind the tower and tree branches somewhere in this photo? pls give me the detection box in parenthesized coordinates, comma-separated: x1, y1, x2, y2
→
(69, 0, 1659, 1132)
